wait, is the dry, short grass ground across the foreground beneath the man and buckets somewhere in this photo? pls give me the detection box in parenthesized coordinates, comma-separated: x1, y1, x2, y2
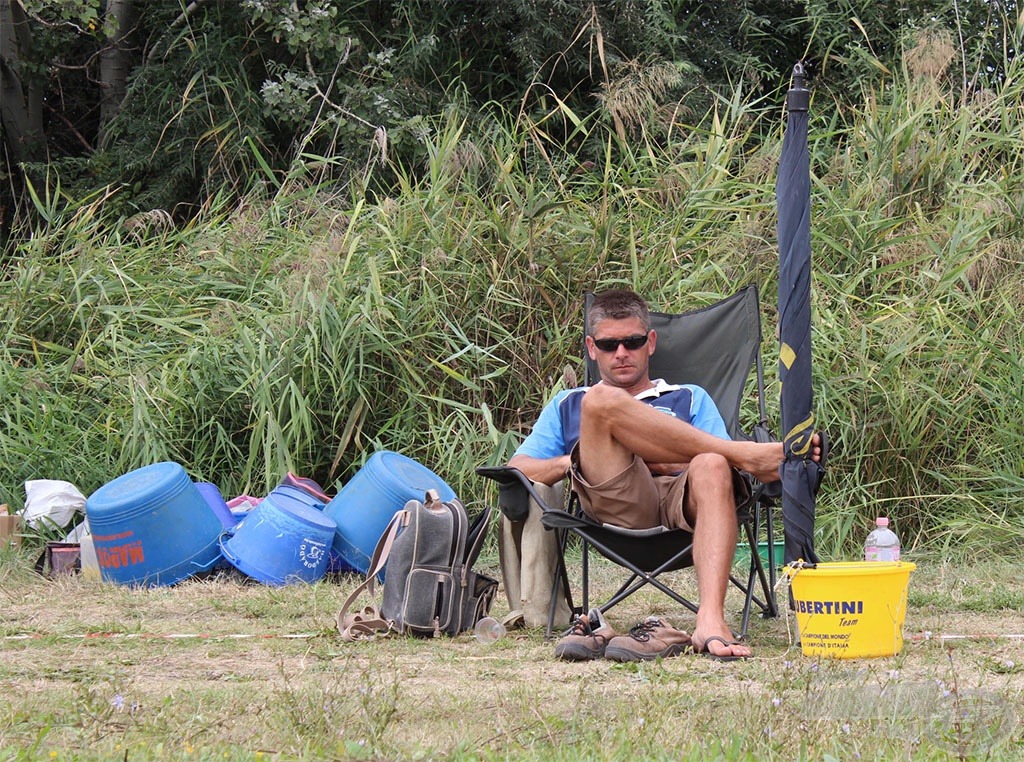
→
(0, 551, 1024, 760)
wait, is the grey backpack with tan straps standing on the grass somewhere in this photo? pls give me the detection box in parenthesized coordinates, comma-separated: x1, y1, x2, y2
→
(338, 490, 498, 640)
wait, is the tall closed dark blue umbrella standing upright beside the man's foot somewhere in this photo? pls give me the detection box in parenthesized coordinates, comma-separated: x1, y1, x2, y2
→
(775, 62, 823, 563)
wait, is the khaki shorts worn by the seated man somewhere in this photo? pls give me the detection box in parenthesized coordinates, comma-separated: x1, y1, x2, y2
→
(569, 443, 750, 532)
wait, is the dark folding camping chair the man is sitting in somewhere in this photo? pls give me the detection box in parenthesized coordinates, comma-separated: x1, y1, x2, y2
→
(476, 286, 778, 637)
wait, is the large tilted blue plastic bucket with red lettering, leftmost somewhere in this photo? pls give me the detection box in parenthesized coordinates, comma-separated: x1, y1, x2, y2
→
(85, 462, 223, 587)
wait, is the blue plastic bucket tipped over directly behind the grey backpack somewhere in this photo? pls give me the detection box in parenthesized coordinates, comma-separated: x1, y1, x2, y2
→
(324, 450, 455, 575)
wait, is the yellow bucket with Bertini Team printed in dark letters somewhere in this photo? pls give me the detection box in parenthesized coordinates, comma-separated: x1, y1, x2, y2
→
(785, 561, 916, 659)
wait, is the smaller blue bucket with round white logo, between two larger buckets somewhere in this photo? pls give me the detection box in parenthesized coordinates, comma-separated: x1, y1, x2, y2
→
(220, 491, 337, 585)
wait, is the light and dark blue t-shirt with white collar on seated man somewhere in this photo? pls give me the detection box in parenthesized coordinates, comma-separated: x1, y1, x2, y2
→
(515, 379, 730, 459)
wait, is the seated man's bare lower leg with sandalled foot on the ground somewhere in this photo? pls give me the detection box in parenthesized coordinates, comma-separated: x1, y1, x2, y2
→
(684, 455, 753, 657)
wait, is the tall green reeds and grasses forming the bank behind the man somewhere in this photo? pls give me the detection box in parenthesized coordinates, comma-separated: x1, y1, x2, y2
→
(0, 29, 1024, 557)
